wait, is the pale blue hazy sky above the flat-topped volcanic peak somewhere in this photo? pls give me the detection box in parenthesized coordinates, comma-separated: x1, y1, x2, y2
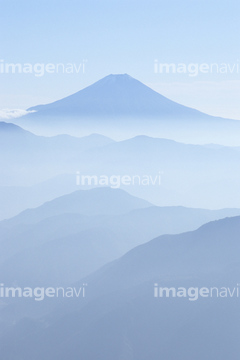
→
(0, 0, 240, 119)
